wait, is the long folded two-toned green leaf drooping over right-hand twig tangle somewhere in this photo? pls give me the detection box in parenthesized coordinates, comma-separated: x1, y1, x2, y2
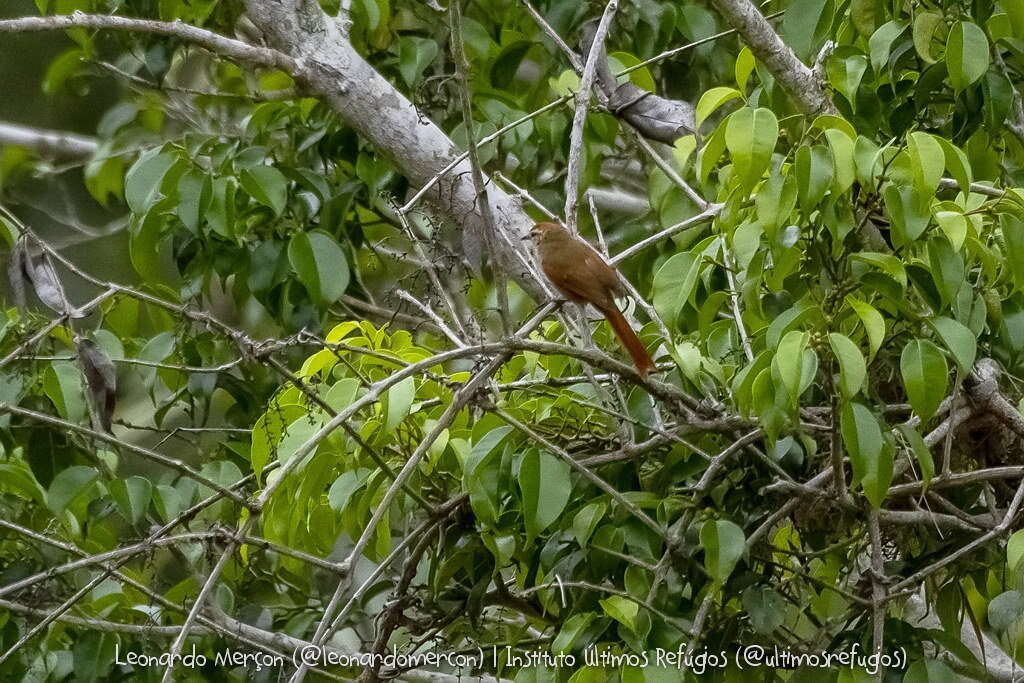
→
(840, 402, 893, 508)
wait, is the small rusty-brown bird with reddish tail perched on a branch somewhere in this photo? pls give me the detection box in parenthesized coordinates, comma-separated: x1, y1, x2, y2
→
(529, 223, 654, 379)
